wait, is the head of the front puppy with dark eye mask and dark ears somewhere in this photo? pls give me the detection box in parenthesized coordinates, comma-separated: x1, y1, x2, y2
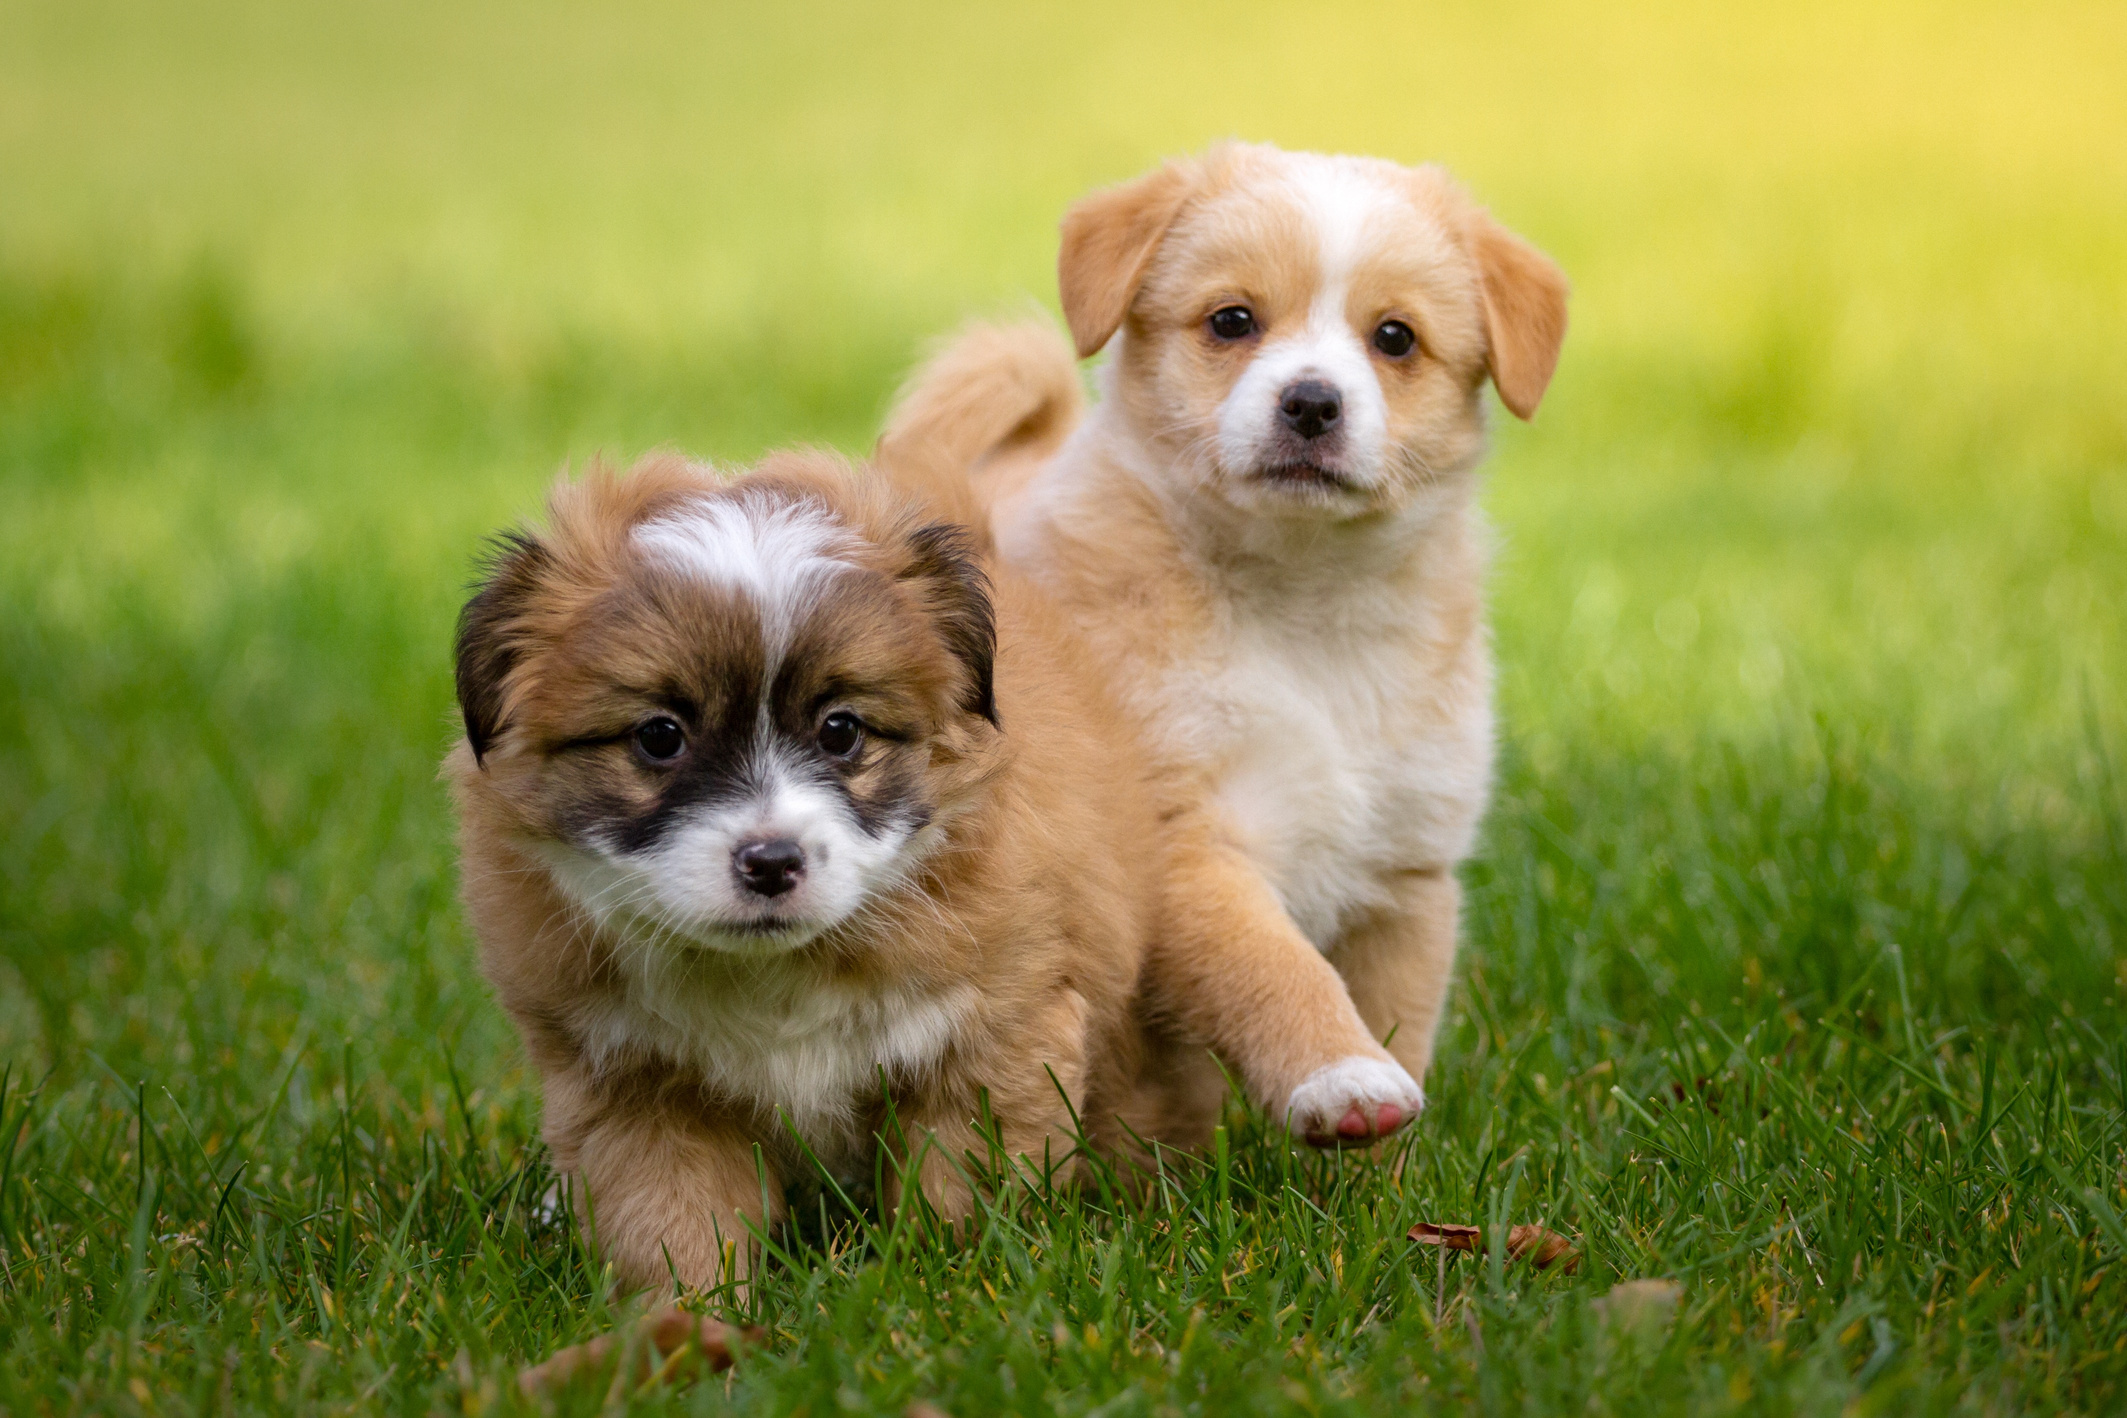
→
(459, 463, 989, 952)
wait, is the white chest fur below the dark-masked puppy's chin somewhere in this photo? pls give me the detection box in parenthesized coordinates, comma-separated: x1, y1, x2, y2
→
(557, 952, 976, 1159)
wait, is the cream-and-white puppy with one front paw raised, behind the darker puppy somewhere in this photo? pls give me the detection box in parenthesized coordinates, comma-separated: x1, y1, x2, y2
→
(881, 147, 1565, 1142)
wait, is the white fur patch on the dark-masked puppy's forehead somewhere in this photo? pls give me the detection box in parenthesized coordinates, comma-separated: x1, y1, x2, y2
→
(636, 497, 855, 663)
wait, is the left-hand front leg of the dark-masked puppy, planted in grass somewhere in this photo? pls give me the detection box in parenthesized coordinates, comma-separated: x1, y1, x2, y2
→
(547, 1080, 783, 1293)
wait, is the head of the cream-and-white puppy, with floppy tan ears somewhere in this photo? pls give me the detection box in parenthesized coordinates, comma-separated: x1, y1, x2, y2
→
(1059, 147, 1565, 517)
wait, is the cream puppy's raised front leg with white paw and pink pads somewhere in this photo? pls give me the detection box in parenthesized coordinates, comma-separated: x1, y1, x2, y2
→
(1146, 827, 1425, 1146)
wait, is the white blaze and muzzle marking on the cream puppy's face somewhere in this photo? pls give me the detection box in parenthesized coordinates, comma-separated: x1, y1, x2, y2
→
(1219, 153, 1404, 483)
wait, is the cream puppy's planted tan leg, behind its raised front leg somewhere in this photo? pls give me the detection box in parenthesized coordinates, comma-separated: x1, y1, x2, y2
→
(1329, 867, 1461, 1084)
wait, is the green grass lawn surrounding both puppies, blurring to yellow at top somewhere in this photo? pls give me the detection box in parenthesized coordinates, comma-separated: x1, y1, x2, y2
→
(0, 0, 2127, 1416)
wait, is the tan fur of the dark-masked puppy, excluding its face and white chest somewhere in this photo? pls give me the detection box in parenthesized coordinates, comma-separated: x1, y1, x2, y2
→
(445, 455, 1219, 1286)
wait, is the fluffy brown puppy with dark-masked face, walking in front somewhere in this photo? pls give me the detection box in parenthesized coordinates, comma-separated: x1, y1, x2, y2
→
(447, 455, 1215, 1286)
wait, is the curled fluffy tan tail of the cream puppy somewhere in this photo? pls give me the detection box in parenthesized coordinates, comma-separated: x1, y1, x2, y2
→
(872, 321, 1085, 548)
